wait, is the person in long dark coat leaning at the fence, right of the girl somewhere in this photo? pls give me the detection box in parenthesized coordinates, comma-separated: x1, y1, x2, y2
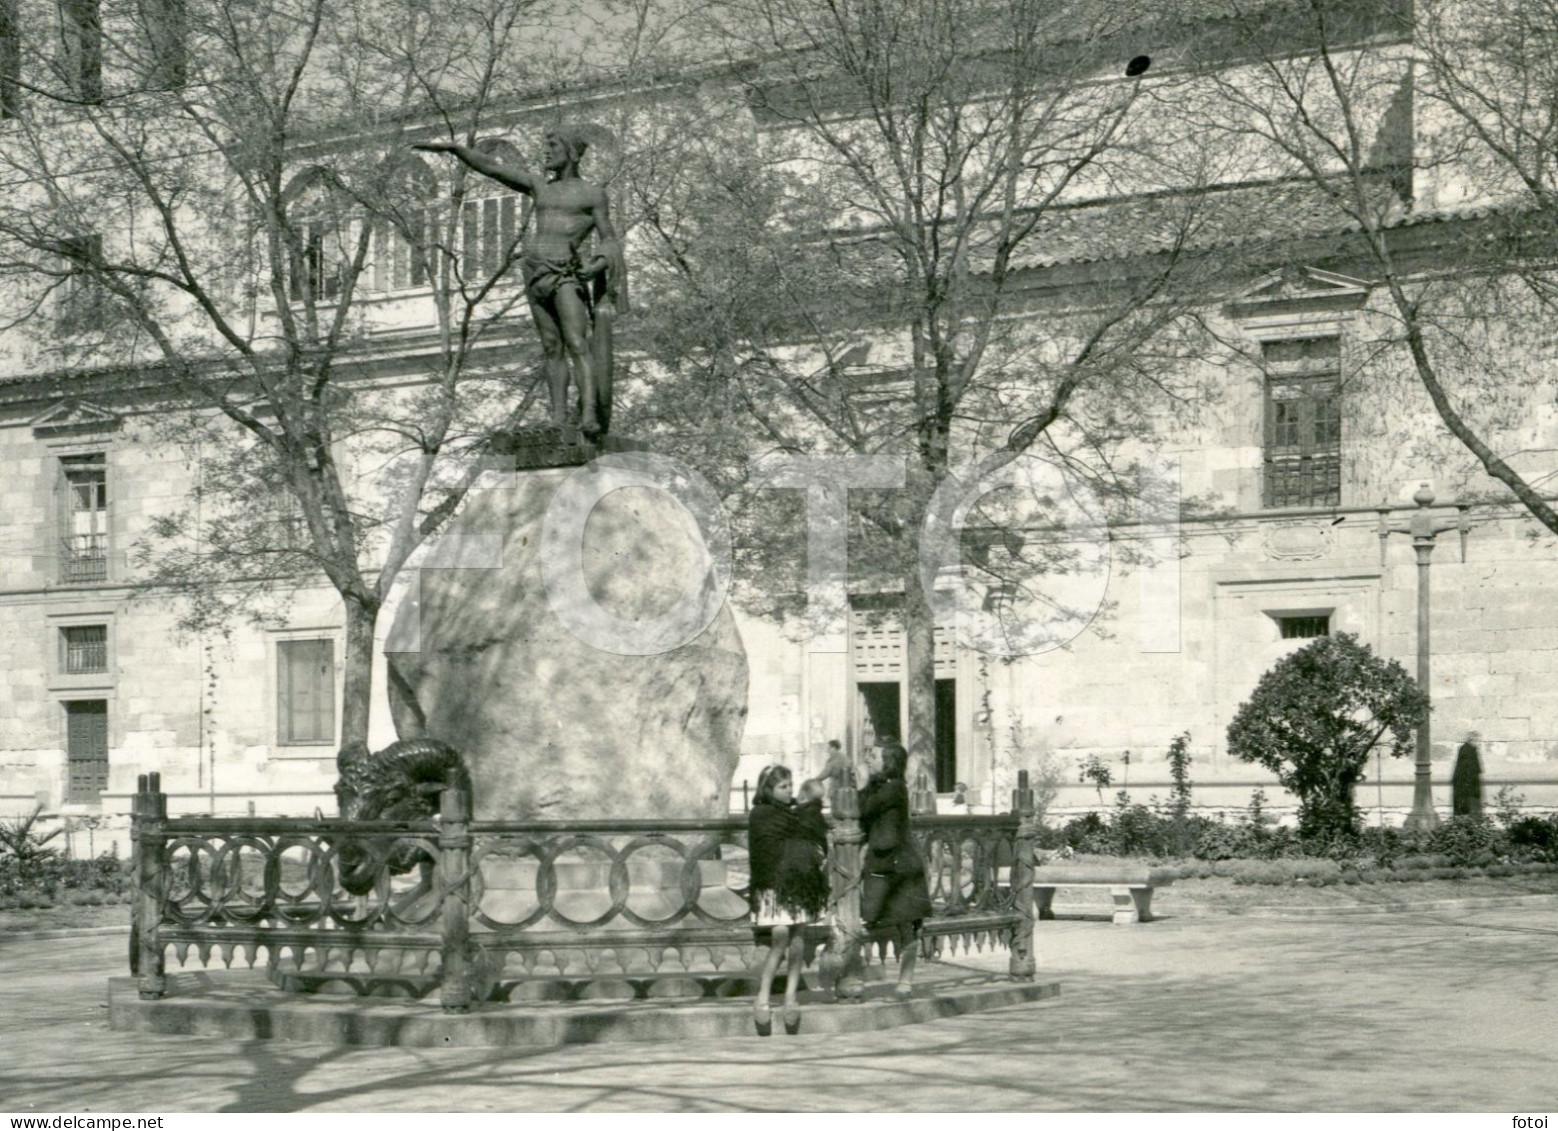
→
(860, 743, 932, 997)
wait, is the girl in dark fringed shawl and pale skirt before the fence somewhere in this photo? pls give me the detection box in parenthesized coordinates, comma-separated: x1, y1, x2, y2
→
(746, 766, 827, 1036)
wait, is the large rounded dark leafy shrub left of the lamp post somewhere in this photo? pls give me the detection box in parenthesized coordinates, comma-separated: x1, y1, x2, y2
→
(1228, 632, 1429, 838)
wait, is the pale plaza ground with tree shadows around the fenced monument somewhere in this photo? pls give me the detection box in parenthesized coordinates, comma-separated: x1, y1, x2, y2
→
(0, 899, 1558, 1112)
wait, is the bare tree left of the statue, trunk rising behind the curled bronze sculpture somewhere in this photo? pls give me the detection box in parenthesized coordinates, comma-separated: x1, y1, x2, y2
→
(0, 0, 582, 763)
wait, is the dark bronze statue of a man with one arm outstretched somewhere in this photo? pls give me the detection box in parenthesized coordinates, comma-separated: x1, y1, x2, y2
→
(411, 129, 628, 439)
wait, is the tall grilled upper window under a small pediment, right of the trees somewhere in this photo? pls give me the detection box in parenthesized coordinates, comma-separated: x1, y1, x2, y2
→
(1262, 338, 1341, 508)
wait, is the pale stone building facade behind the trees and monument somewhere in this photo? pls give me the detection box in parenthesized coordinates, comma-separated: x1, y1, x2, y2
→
(0, 0, 1558, 846)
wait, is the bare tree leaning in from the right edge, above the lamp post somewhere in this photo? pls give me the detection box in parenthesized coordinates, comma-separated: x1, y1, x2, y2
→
(1201, 0, 1558, 533)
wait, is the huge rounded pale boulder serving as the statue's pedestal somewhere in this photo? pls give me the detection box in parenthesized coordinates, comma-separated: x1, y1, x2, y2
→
(388, 469, 746, 819)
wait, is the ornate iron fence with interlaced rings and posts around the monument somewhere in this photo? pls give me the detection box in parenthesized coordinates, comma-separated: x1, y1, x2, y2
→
(131, 774, 1036, 1011)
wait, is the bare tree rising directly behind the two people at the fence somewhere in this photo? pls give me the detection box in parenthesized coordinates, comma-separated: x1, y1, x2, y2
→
(626, 0, 1214, 797)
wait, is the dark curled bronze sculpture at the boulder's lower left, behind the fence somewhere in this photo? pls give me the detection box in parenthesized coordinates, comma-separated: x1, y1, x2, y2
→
(335, 738, 471, 896)
